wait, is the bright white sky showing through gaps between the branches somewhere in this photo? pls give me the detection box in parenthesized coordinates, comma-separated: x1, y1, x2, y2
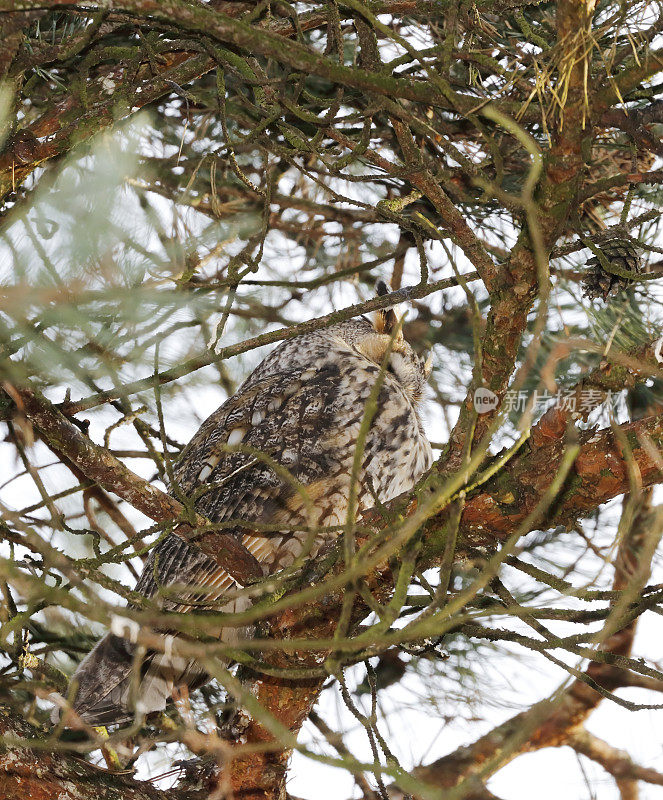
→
(0, 114, 663, 800)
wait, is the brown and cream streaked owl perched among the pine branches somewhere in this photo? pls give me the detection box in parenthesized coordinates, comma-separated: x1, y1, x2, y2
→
(66, 309, 432, 725)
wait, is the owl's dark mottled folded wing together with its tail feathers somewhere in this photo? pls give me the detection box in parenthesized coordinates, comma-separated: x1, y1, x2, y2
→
(67, 366, 348, 724)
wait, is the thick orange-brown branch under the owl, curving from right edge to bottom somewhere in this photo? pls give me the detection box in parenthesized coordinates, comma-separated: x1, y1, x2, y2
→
(187, 415, 663, 800)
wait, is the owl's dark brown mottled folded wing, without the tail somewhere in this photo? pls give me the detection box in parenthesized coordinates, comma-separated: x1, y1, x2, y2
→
(136, 366, 339, 610)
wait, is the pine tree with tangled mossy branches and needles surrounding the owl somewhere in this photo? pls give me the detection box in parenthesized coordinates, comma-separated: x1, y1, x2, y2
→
(0, 0, 663, 800)
